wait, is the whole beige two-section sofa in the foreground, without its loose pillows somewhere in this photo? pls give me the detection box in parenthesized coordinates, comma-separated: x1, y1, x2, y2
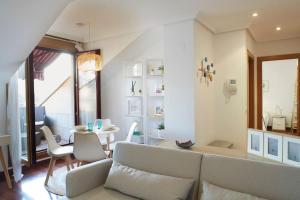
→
(66, 143, 300, 200)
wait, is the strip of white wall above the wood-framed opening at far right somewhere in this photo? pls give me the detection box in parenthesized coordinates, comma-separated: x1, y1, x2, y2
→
(255, 38, 300, 56)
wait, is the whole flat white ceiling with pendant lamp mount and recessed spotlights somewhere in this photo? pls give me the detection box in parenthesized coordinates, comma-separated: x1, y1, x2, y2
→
(49, 0, 300, 42)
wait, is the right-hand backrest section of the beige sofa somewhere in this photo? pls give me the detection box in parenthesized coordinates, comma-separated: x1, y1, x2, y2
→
(199, 155, 300, 200)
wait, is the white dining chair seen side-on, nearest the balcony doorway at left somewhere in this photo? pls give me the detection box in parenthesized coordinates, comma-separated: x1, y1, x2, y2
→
(41, 126, 74, 185)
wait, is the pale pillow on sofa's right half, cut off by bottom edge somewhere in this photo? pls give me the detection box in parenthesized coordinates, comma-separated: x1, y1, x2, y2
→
(201, 181, 266, 200)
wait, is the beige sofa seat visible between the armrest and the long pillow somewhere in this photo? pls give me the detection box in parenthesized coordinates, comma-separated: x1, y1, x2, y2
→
(69, 185, 136, 200)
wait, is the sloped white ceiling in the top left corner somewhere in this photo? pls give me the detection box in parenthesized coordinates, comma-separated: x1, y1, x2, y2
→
(0, 0, 71, 82)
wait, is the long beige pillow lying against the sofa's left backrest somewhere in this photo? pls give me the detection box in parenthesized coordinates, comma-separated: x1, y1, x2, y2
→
(104, 163, 194, 200)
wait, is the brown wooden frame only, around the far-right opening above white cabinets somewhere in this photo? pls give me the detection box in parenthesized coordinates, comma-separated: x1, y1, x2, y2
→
(257, 53, 300, 135)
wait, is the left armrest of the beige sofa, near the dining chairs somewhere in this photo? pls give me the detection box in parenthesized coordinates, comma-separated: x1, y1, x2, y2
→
(66, 159, 113, 198)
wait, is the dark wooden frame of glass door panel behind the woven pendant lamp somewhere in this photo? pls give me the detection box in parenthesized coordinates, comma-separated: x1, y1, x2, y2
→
(74, 49, 101, 125)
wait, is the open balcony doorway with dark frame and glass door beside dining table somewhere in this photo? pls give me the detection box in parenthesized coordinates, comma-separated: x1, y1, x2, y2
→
(25, 38, 101, 165)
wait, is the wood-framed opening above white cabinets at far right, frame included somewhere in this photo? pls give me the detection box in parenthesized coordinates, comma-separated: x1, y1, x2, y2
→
(257, 54, 300, 135)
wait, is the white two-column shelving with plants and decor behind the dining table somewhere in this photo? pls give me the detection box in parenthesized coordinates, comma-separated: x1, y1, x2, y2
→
(124, 59, 165, 144)
